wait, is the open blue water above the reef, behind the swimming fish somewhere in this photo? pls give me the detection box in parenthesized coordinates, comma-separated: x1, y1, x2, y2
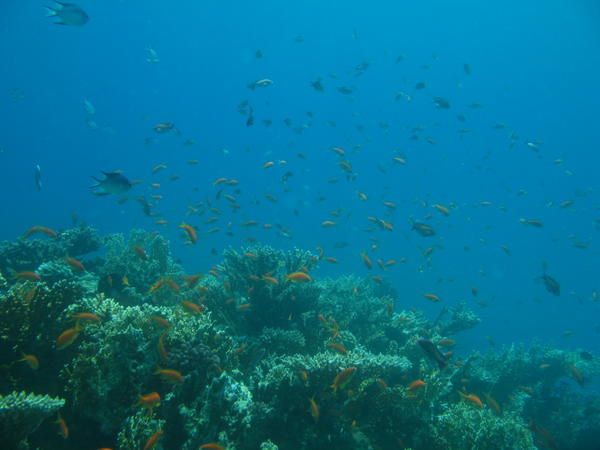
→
(0, 0, 600, 351)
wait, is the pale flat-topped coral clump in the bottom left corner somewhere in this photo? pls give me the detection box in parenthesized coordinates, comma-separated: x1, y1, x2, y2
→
(0, 392, 65, 449)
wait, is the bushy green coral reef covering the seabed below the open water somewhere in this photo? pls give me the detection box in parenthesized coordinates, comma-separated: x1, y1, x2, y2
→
(0, 228, 600, 450)
